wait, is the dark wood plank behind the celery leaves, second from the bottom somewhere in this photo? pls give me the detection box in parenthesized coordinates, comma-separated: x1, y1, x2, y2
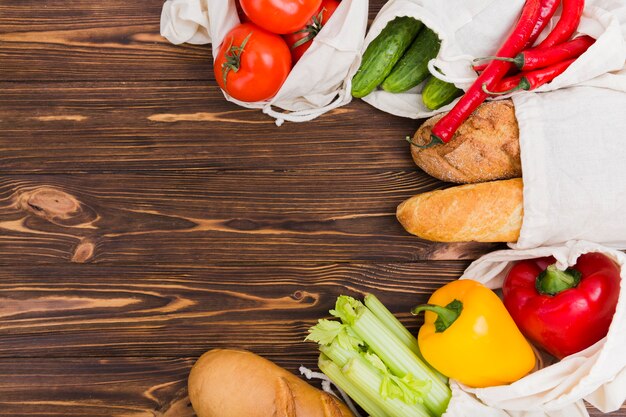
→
(0, 261, 469, 354)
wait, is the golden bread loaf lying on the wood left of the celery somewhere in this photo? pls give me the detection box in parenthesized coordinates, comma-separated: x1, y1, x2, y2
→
(189, 349, 354, 417)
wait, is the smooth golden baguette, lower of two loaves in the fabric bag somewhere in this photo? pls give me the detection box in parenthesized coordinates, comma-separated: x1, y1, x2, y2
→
(396, 178, 523, 242)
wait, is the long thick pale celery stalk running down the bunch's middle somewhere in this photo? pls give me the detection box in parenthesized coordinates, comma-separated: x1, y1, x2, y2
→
(349, 306, 451, 416)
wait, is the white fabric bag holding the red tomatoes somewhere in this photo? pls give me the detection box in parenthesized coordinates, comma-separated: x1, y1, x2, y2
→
(161, 0, 369, 125)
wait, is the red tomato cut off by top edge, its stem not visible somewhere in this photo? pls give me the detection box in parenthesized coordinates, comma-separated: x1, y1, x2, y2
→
(240, 0, 322, 34)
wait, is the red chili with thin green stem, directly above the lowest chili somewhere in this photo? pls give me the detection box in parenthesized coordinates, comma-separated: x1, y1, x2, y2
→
(476, 35, 596, 71)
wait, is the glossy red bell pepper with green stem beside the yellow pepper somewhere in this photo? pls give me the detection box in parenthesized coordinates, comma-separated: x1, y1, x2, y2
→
(502, 253, 620, 359)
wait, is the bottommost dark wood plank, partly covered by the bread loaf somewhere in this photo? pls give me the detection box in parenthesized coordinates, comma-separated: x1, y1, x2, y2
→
(0, 353, 626, 417)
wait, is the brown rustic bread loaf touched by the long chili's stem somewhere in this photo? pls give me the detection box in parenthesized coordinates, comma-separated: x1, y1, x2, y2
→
(411, 100, 522, 183)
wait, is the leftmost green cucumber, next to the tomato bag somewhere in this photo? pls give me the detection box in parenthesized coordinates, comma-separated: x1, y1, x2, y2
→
(352, 16, 423, 98)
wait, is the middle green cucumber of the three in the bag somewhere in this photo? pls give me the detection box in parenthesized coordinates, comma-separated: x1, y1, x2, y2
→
(381, 27, 441, 93)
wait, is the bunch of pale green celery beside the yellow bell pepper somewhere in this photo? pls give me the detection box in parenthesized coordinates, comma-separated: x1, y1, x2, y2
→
(306, 296, 451, 417)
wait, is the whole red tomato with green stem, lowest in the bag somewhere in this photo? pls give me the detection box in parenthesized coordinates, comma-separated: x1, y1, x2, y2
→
(213, 23, 291, 102)
